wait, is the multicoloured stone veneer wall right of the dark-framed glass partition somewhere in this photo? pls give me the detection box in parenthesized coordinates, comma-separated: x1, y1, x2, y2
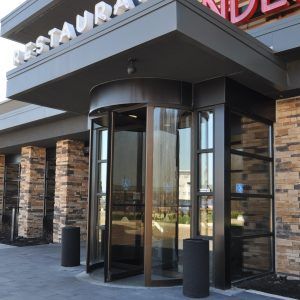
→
(275, 98, 300, 276)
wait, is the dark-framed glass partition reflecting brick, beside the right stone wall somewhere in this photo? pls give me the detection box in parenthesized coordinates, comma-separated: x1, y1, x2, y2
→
(230, 113, 273, 280)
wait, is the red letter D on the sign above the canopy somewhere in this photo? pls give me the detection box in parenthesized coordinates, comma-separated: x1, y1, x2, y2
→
(230, 0, 258, 25)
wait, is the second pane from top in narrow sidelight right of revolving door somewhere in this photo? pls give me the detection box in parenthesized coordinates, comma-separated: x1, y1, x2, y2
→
(198, 153, 213, 193)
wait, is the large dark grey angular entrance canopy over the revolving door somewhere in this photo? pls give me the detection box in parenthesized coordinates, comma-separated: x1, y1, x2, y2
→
(3, 0, 287, 113)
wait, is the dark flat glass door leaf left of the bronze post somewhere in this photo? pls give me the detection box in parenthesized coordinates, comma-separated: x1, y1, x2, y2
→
(106, 108, 146, 281)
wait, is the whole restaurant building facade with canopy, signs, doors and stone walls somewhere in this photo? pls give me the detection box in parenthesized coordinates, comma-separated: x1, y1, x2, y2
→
(0, 0, 300, 289)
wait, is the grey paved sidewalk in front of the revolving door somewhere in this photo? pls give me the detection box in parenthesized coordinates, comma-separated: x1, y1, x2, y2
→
(0, 245, 286, 300)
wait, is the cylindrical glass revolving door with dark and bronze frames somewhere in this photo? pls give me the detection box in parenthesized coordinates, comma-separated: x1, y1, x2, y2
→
(88, 105, 192, 286)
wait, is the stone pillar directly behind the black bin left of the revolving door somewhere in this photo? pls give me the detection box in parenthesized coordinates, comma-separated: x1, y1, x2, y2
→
(53, 140, 89, 242)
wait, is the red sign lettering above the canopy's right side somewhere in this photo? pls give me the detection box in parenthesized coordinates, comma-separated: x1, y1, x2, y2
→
(202, 0, 300, 25)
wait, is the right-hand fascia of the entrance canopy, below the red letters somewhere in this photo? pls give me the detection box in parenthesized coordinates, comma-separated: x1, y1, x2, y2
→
(178, 1, 286, 89)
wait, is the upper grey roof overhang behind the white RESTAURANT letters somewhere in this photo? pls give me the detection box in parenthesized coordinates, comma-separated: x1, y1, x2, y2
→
(1, 0, 106, 43)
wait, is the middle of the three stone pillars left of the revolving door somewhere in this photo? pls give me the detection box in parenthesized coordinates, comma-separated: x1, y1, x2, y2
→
(18, 146, 46, 238)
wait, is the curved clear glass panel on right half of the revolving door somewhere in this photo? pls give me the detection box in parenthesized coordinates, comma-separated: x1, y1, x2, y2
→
(152, 108, 191, 280)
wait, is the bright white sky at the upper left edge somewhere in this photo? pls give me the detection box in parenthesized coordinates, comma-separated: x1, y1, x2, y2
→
(0, 0, 25, 102)
